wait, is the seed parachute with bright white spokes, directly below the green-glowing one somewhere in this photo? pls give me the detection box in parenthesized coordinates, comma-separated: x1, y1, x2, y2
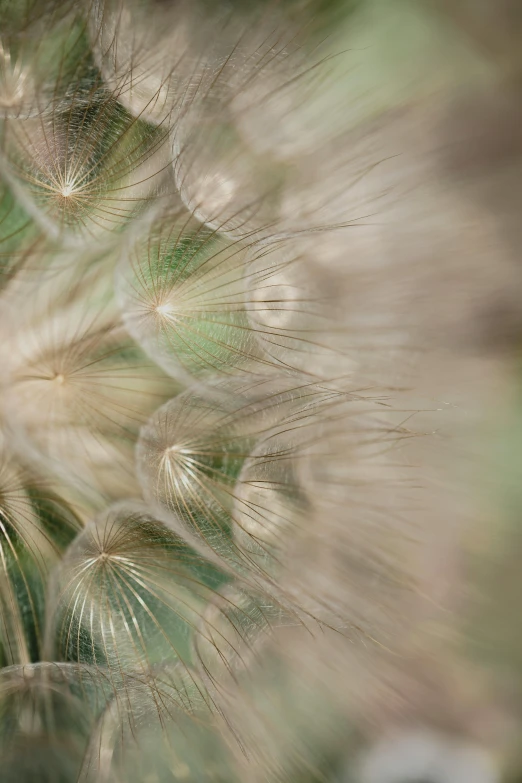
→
(136, 375, 352, 595)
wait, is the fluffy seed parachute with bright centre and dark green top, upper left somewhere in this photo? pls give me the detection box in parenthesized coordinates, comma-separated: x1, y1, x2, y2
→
(6, 59, 169, 243)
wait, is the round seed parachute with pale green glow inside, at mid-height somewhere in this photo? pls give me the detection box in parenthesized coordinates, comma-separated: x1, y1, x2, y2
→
(116, 204, 262, 382)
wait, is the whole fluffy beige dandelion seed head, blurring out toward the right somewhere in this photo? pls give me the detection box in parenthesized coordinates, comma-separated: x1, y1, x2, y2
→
(0, 0, 520, 783)
